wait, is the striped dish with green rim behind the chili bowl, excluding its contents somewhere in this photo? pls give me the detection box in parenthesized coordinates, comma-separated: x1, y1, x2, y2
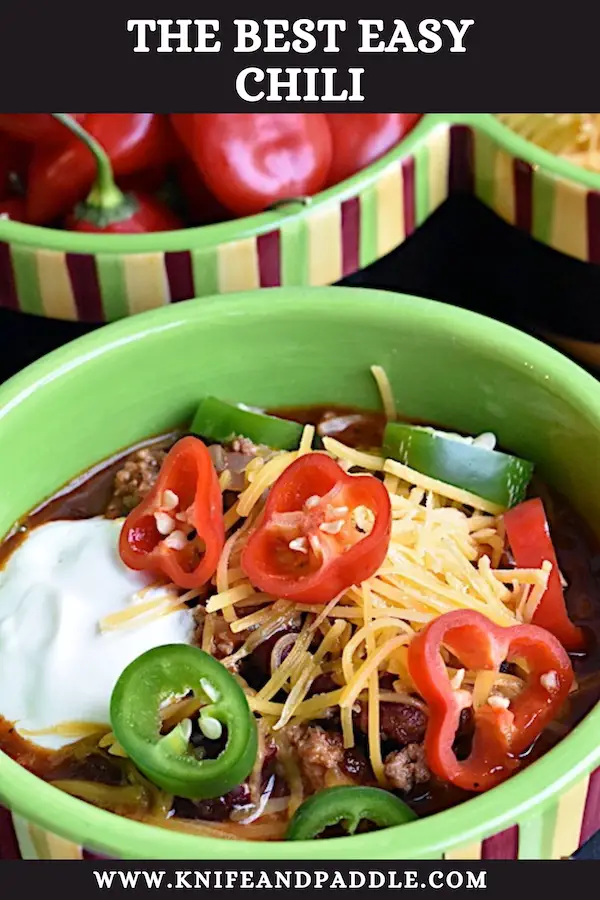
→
(0, 114, 600, 356)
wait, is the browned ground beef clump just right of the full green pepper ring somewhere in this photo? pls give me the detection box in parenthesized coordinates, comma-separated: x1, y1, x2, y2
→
(288, 725, 371, 792)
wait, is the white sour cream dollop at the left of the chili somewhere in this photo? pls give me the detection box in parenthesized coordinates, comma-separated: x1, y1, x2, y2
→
(0, 518, 194, 748)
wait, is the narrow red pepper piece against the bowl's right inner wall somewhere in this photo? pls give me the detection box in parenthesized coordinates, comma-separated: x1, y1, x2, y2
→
(504, 497, 585, 650)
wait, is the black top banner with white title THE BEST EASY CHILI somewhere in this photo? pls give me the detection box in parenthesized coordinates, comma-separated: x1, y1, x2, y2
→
(0, 0, 600, 112)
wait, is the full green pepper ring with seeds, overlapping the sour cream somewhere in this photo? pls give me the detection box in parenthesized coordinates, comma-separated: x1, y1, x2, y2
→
(110, 644, 258, 800)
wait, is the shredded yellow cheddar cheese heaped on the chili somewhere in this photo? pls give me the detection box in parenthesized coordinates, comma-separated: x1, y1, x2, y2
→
(88, 366, 552, 827)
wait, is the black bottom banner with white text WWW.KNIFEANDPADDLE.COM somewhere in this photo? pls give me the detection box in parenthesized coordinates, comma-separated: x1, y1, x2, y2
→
(0, 861, 584, 900)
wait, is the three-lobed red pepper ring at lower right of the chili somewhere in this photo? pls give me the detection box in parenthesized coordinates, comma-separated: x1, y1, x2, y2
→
(408, 609, 573, 791)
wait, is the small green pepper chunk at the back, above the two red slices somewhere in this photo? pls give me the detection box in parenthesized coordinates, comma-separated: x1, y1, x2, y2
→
(190, 397, 303, 450)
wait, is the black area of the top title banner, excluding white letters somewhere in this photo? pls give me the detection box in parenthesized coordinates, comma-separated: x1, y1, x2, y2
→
(0, 0, 600, 112)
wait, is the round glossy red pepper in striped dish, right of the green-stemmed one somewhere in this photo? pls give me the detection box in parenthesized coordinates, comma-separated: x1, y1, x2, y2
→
(171, 113, 332, 216)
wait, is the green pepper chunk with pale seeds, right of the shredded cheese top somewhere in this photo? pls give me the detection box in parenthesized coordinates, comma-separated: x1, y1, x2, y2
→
(383, 422, 533, 509)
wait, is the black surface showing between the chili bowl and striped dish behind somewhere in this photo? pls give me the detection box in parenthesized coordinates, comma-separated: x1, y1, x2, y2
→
(0, 197, 600, 859)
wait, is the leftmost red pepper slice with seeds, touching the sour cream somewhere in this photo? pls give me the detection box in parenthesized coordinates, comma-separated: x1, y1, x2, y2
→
(119, 437, 225, 589)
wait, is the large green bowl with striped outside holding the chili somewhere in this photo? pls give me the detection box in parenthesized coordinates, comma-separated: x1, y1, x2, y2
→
(0, 288, 600, 860)
